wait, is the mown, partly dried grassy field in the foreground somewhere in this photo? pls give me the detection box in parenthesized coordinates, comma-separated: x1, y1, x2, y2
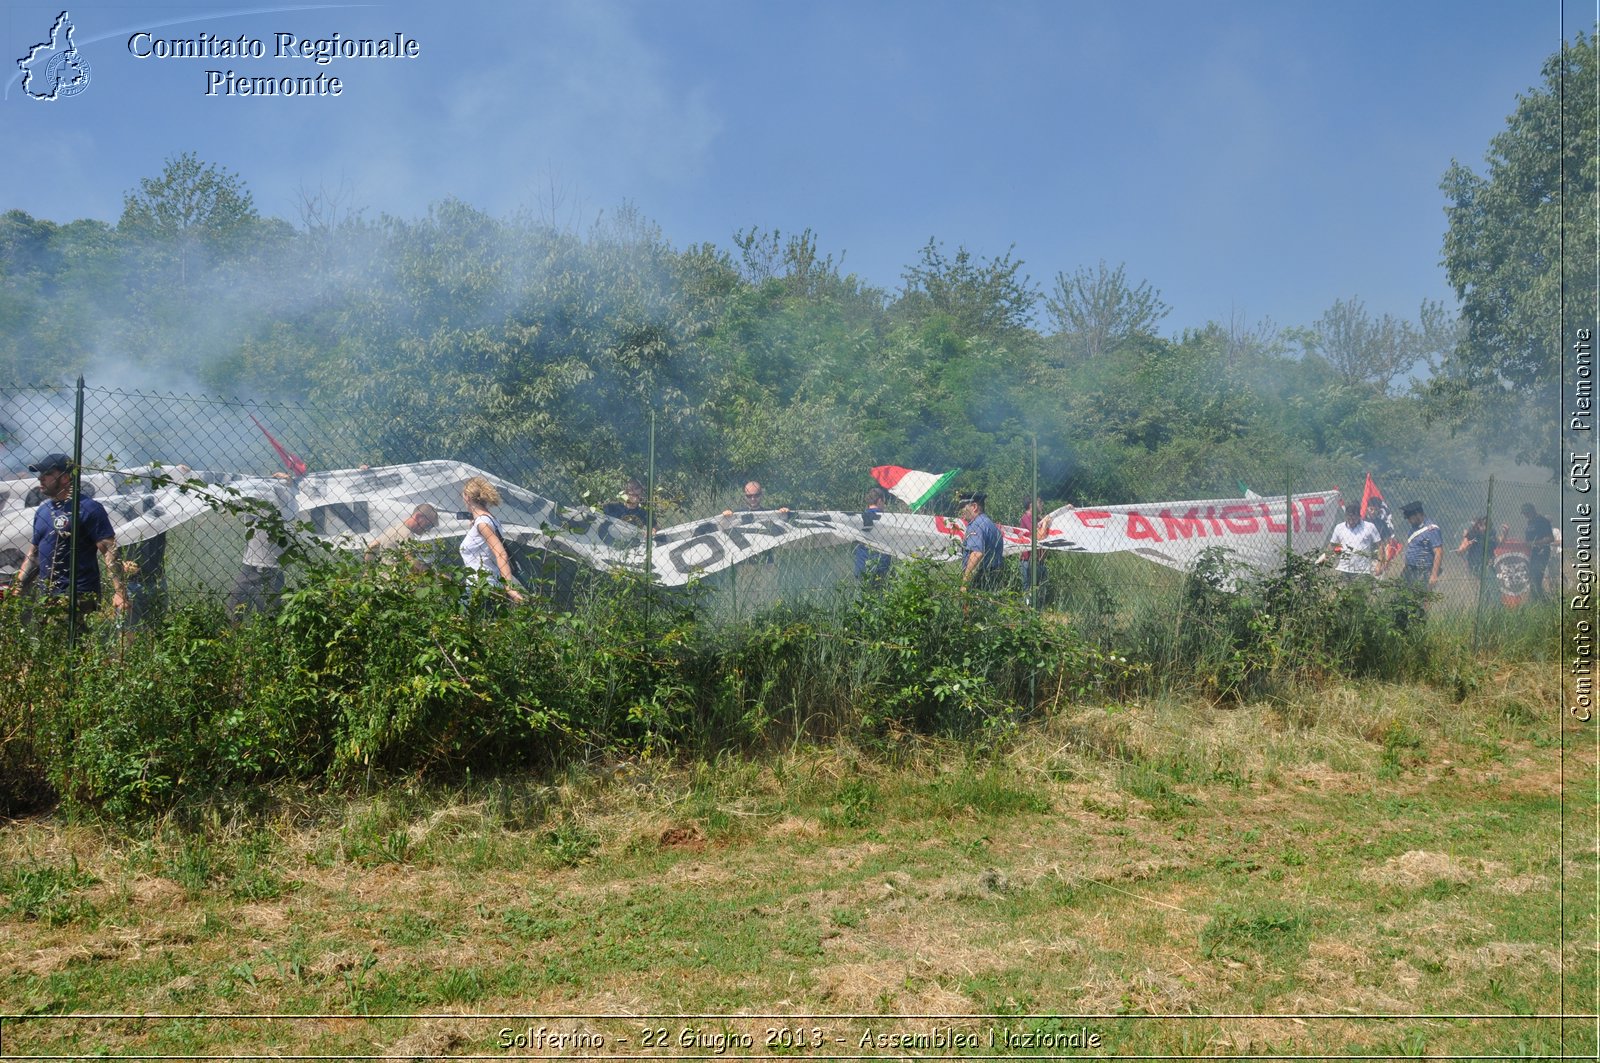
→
(0, 664, 1597, 1058)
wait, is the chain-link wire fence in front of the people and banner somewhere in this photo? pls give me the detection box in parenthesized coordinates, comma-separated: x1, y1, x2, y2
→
(0, 384, 1562, 646)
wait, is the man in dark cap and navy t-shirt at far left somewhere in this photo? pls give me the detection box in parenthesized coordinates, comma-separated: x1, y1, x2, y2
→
(16, 455, 128, 620)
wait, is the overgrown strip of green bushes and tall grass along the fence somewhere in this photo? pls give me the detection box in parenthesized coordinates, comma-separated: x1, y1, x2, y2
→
(0, 556, 1550, 821)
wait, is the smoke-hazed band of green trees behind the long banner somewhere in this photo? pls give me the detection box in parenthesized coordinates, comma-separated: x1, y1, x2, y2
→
(0, 155, 1497, 519)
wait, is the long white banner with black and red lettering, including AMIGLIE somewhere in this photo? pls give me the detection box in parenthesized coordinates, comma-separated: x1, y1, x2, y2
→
(0, 461, 1338, 586)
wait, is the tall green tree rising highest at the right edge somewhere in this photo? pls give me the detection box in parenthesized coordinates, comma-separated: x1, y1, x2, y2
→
(1432, 34, 1600, 469)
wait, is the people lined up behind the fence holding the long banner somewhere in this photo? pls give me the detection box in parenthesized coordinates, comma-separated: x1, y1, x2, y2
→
(11, 453, 1558, 626)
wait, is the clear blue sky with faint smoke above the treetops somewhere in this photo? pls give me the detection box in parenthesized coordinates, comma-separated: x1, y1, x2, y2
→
(0, 0, 1574, 331)
